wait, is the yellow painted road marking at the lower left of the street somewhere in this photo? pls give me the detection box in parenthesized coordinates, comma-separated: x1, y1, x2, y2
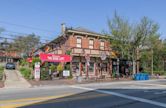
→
(0, 93, 73, 108)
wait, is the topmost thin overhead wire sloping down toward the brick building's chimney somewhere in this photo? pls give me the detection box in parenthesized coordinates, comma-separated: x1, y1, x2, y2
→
(0, 21, 55, 33)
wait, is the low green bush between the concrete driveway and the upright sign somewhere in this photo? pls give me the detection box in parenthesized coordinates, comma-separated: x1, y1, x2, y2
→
(20, 67, 32, 79)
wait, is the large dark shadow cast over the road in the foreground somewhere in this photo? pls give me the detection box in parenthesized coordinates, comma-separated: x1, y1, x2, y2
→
(18, 89, 166, 108)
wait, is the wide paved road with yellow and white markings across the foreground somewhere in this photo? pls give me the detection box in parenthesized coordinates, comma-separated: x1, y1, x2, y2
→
(0, 80, 166, 108)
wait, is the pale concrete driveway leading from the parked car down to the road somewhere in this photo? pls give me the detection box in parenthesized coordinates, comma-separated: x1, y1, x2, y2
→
(4, 70, 31, 88)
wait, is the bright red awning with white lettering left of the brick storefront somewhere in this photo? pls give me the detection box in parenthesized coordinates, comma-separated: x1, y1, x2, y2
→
(40, 53, 72, 62)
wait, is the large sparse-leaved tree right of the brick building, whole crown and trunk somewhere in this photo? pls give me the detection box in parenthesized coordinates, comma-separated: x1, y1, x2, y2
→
(107, 12, 159, 74)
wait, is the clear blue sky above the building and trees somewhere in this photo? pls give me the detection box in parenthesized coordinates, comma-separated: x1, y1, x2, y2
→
(0, 0, 166, 40)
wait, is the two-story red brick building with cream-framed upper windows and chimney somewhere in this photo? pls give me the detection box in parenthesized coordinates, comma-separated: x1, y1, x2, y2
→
(38, 24, 112, 77)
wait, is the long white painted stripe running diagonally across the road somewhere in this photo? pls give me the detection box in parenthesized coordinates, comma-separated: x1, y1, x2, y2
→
(71, 86, 166, 108)
